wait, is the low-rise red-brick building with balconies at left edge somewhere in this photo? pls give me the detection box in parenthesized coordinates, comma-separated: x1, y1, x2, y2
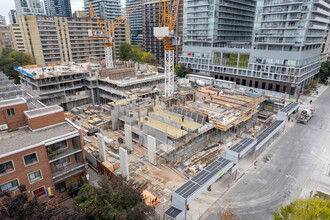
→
(0, 98, 87, 202)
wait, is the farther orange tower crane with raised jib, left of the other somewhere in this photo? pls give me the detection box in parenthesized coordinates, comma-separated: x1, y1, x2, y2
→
(88, 0, 145, 68)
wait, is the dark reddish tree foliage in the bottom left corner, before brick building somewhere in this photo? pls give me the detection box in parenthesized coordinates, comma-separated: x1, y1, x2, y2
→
(0, 185, 86, 220)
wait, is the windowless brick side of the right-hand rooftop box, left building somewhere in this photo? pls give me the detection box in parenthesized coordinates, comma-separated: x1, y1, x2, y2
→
(27, 111, 64, 130)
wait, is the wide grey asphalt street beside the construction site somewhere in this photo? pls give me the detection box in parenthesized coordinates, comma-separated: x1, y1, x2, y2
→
(200, 86, 330, 220)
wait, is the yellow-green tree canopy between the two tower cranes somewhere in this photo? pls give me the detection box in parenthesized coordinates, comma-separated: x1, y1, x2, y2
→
(119, 42, 157, 64)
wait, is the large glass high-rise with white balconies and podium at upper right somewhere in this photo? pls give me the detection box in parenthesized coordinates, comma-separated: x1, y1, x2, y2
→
(180, 0, 330, 94)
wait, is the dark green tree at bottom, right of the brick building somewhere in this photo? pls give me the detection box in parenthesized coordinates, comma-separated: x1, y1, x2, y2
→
(76, 176, 154, 220)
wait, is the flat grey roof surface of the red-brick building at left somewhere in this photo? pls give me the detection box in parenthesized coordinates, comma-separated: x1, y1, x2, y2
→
(0, 122, 76, 158)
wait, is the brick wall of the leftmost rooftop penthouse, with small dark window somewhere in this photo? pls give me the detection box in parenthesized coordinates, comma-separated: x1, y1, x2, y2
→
(0, 103, 28, 130)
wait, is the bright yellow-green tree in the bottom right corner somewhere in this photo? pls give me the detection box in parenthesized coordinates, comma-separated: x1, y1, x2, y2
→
(274, 198, 330, 220)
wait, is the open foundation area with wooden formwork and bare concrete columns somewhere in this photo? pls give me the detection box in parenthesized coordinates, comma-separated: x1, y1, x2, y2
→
(54, 79, 297, 215)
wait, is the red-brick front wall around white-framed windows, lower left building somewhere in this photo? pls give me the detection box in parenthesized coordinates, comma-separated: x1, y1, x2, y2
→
(0, 145, 55, 202)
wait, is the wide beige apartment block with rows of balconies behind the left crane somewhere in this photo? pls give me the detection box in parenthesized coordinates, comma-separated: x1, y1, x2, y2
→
(18, 13, 131, 66)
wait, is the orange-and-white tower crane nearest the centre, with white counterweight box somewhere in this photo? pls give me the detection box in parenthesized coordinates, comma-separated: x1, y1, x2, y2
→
(154, 0, 180, 98)
